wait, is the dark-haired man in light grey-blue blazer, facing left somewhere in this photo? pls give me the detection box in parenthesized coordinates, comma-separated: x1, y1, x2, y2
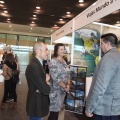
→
(85, 33, 120, 120)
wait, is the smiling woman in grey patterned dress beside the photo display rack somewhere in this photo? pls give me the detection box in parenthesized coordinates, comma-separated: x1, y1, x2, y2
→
(48, 43, 69, 120)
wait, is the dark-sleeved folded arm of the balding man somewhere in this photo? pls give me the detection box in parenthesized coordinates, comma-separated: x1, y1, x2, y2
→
(26, 64, 50, 95)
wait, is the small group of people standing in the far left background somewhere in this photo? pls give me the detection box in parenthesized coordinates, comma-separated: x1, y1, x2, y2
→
(0, 47, 20, 109)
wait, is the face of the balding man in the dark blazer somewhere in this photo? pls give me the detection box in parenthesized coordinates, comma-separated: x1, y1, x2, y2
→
(37, 43, 49, 60)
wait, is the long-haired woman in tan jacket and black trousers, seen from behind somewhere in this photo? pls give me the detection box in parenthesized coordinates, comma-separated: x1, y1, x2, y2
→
(1, 53, 17, 109)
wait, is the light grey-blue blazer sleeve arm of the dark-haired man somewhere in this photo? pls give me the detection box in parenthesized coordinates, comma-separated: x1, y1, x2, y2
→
(86, 55, 116, 114)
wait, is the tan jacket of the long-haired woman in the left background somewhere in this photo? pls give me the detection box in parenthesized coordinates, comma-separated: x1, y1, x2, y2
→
(2, 64, 12, 80)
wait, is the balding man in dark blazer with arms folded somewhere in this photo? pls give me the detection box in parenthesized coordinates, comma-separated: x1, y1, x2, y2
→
(25, 42, 50, 120)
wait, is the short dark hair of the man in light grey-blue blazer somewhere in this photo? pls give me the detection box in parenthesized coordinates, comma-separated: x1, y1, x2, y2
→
(101, 33, 118, 47)
